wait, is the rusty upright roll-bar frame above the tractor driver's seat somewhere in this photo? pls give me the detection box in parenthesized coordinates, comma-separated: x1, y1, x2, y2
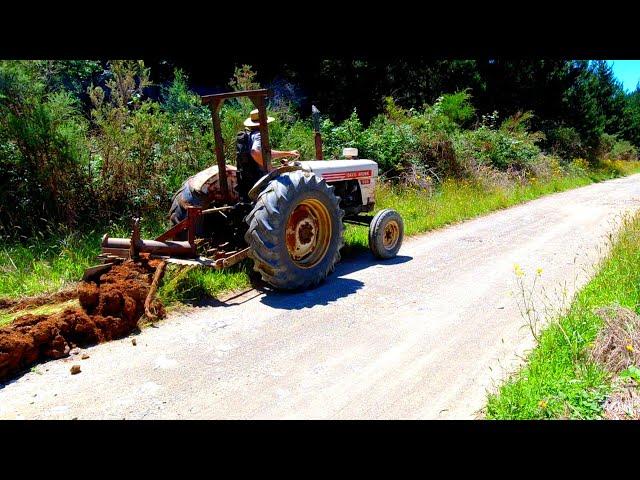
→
(202, 89, 272, 201)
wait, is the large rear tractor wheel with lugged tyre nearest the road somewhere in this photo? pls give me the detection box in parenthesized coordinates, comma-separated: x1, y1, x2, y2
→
(245, 170, 344, 290)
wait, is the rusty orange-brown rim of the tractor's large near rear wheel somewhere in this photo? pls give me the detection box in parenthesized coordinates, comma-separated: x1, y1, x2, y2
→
(286, 199, 331, 268)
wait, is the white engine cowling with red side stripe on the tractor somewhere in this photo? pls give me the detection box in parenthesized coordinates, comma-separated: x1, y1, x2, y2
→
(300, 160, 378, 210)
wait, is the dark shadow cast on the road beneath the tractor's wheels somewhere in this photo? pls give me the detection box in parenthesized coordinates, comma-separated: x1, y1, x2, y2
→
(254, 253, 413, 310)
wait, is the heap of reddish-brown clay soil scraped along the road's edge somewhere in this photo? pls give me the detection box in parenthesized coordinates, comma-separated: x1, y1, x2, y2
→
(0, 258, 164, 380)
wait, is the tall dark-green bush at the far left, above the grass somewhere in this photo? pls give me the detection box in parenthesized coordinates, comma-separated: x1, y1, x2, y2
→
(0, 61, 91, 235)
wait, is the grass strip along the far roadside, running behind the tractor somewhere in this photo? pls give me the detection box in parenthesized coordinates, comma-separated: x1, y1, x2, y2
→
(0, 162, 640, 312)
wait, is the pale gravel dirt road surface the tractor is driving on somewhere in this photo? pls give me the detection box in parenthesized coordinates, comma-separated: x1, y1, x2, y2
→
(0, 175, 640, 419)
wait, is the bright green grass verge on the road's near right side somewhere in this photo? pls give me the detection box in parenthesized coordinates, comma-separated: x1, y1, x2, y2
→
(486, 209, 640, 419)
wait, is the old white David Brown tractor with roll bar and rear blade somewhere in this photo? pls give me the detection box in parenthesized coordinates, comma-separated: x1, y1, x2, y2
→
(84, 89, 404, 290)
